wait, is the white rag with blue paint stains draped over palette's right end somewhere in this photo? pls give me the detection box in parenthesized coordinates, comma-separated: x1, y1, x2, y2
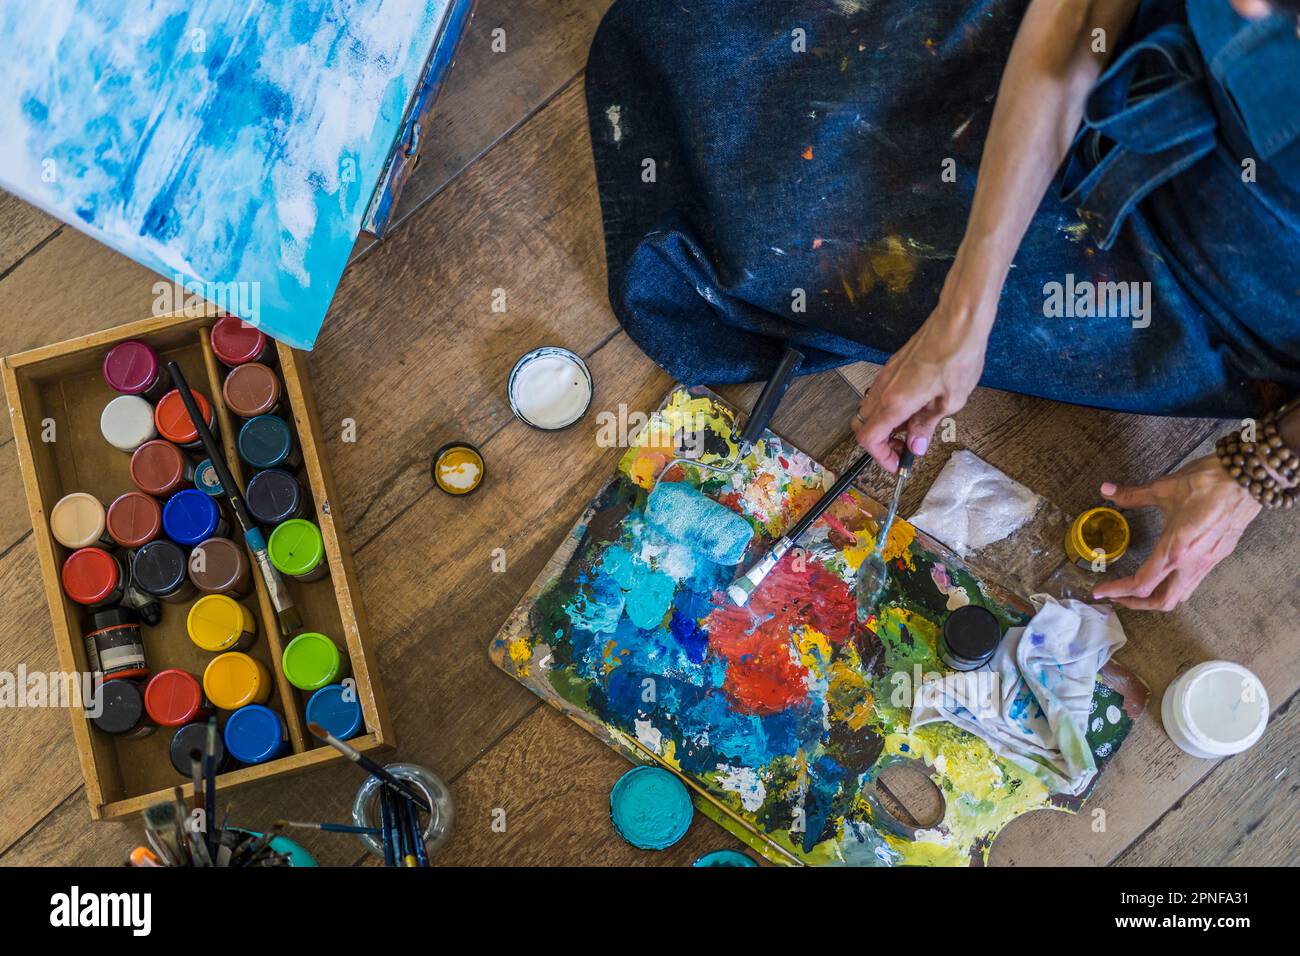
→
(911, 594, 1127, 795)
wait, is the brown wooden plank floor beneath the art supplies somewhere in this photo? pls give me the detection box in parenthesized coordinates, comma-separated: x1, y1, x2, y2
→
(0, 0, 1300, 865)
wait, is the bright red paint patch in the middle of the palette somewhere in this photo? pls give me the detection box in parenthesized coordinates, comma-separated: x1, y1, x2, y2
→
(705, 554, 858, 714)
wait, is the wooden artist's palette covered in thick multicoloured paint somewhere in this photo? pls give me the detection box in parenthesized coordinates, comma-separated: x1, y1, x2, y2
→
(490, 388, 1147, 865)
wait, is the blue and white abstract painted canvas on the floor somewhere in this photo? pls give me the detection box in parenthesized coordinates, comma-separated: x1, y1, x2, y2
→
(0, 0, 450, 349)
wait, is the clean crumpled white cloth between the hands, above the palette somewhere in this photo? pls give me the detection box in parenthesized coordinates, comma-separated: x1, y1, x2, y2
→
(907, 449, 1043, 558)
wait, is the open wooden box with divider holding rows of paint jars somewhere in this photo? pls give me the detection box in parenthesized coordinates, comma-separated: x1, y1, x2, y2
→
(4, 315, 395, 819)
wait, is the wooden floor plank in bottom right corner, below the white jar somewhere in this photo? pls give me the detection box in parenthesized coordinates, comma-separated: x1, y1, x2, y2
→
(1115, 697, 1300, 866)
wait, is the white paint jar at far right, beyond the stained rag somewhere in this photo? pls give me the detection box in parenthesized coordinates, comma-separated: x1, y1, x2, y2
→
(1160, 661, 1269, 760)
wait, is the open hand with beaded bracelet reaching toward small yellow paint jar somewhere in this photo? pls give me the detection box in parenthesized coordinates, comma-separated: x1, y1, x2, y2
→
(1092, 455, 1262, 611)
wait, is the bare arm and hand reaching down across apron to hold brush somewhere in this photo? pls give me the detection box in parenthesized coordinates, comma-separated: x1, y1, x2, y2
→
(853, 0, 1138, 471)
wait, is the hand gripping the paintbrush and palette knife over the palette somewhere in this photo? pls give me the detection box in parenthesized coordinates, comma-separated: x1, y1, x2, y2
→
(853, 306, 988, 472)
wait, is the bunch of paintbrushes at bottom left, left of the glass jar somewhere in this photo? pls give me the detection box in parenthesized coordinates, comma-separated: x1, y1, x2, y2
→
(130, 717, 289, 866)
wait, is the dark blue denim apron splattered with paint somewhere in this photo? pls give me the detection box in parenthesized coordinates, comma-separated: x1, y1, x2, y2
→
(586, 0, 1300, 416)
